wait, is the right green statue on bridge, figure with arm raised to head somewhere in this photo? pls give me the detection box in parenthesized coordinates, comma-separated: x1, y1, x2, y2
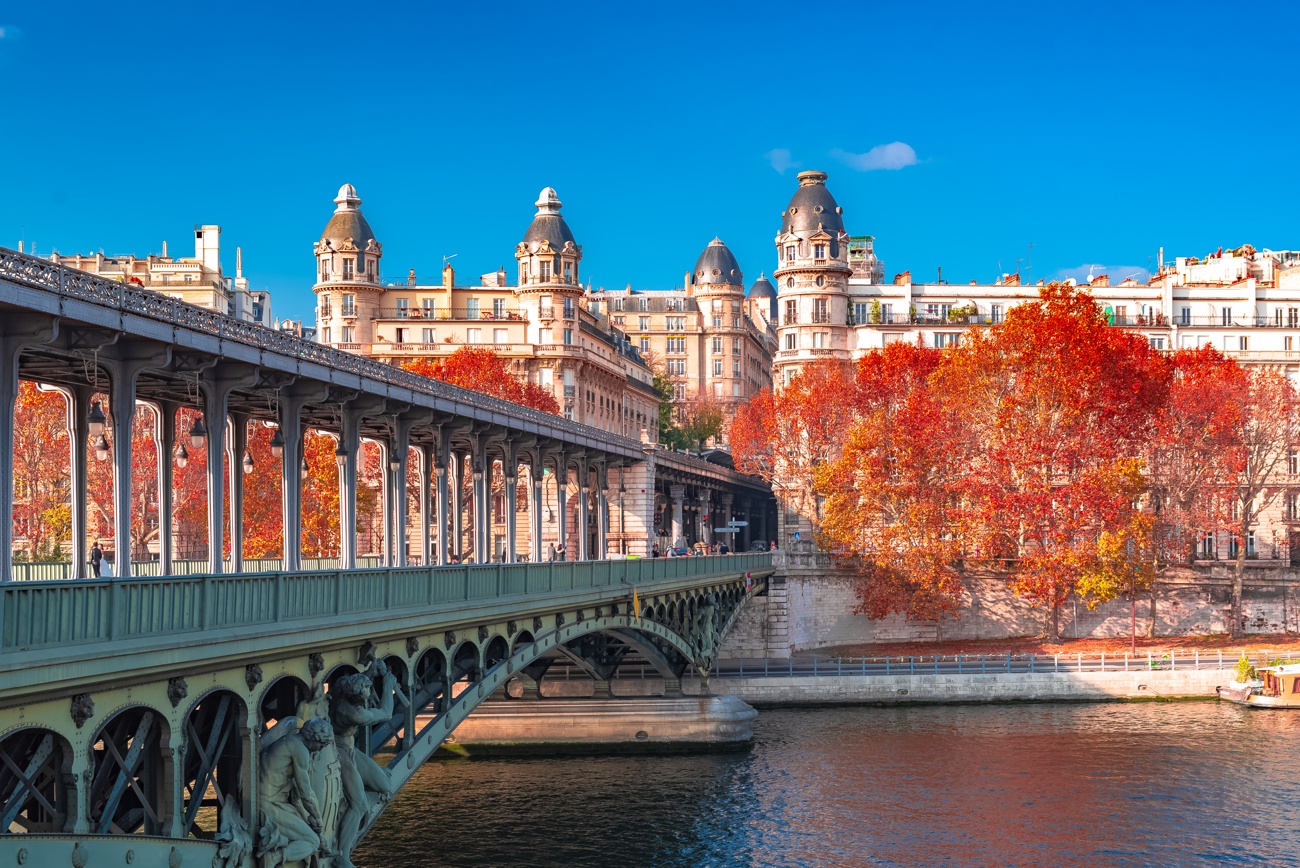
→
(329, 661, 397, 868)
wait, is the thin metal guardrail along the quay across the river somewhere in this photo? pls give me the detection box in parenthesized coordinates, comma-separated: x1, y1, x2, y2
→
(712, 651, 1248, 678)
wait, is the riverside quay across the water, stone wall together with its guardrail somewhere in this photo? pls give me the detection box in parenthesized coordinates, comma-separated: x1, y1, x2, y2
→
(683, 652, 1237, 708)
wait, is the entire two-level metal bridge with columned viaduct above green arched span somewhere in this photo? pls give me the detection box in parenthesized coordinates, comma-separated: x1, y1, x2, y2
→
(0, 248, 772, 868)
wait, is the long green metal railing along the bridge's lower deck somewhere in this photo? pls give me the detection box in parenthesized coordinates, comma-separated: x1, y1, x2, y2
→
(0, 552, 772, 651)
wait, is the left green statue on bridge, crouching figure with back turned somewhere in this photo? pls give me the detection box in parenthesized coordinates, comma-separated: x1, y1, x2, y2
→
(257, 717, 334, 865)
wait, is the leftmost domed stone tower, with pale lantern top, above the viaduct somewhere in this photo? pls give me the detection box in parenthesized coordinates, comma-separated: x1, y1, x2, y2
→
(312, 183, 384, 350)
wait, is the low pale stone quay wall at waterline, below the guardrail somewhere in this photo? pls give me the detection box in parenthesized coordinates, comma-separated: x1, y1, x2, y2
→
(683, 669, 1234, 707)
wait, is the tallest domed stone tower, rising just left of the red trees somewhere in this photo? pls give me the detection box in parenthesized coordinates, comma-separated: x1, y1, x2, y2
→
(772, 172, 853, 389)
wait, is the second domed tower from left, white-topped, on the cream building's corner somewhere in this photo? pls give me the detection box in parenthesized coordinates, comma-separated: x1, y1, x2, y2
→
(515, 187, 582, 343)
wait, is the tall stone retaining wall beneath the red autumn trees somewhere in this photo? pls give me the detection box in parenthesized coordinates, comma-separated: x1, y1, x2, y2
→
(720, 551, 1300, 657)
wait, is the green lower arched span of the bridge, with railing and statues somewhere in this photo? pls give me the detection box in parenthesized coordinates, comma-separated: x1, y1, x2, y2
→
(0, 554, 772, 867)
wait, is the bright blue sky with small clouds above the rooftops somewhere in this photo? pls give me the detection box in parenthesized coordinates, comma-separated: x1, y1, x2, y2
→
(0, 3, 1300, 323)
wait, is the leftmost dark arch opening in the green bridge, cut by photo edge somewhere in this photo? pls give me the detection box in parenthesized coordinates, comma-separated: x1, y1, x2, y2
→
(0, 726, 77, 836)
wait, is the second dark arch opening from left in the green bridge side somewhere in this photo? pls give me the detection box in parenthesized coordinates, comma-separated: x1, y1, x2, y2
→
(86, 704, 172, 836)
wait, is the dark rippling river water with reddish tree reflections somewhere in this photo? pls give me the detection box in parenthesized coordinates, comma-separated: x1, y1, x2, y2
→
(356, 702, 1300, 868)
